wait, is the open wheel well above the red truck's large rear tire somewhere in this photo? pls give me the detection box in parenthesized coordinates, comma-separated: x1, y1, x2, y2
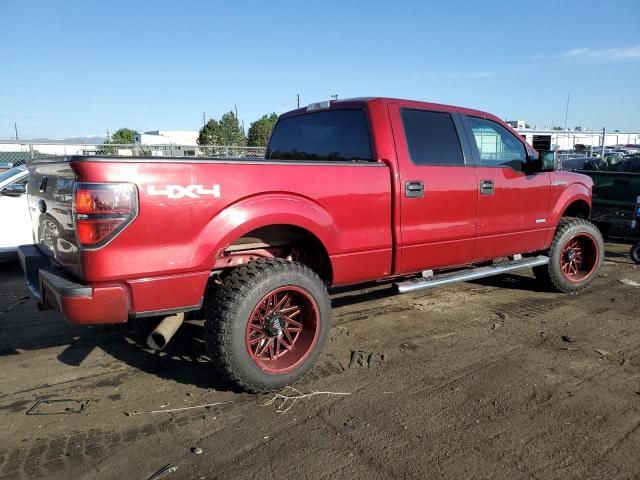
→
(220, 225, 333, 285)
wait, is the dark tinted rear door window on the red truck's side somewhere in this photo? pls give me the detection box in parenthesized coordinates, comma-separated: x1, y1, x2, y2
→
(401, 108, 464, 165)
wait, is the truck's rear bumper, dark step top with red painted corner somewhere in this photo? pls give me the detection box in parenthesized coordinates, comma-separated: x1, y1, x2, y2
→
(18, 245, 129, 325)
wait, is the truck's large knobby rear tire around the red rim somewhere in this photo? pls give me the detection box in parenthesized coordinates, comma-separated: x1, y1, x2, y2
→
(205, 258, 331, 392)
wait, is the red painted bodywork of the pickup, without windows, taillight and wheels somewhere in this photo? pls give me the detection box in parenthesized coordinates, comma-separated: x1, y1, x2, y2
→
(23, 98, 592, 323)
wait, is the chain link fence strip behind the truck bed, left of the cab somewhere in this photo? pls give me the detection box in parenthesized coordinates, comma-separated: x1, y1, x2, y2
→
(0, 142, 266, 170)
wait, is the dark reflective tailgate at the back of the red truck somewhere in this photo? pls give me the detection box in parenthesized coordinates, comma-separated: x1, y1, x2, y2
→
(27, 158, 81, 276)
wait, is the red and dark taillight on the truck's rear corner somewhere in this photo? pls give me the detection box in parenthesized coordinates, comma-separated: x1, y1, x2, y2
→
(73, 183, 138, 248)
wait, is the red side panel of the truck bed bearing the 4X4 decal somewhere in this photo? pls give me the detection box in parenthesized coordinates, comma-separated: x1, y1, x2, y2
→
(73, 160, 392, 284)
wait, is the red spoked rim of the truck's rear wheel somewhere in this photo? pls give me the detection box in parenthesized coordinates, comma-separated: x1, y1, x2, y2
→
(245, 285, 320, 373)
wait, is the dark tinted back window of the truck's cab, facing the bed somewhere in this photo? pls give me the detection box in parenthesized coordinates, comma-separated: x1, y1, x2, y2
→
(266, 109, 372, 161)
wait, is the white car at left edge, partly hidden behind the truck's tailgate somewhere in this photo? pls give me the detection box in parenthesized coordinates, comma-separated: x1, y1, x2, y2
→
(0, 165, 33, 262)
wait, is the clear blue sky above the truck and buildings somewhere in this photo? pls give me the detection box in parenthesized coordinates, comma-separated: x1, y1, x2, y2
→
(0, 0, 640, 139)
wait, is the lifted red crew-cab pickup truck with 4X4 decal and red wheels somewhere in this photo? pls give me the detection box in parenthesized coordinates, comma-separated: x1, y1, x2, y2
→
(19, 98, 603, 391)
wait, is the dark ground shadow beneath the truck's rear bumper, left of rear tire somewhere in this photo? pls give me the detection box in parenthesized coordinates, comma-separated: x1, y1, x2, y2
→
(0, 268, 237, 391)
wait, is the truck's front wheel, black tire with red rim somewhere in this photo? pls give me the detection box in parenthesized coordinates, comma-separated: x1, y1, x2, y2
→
(533, 217, 604, 293)
